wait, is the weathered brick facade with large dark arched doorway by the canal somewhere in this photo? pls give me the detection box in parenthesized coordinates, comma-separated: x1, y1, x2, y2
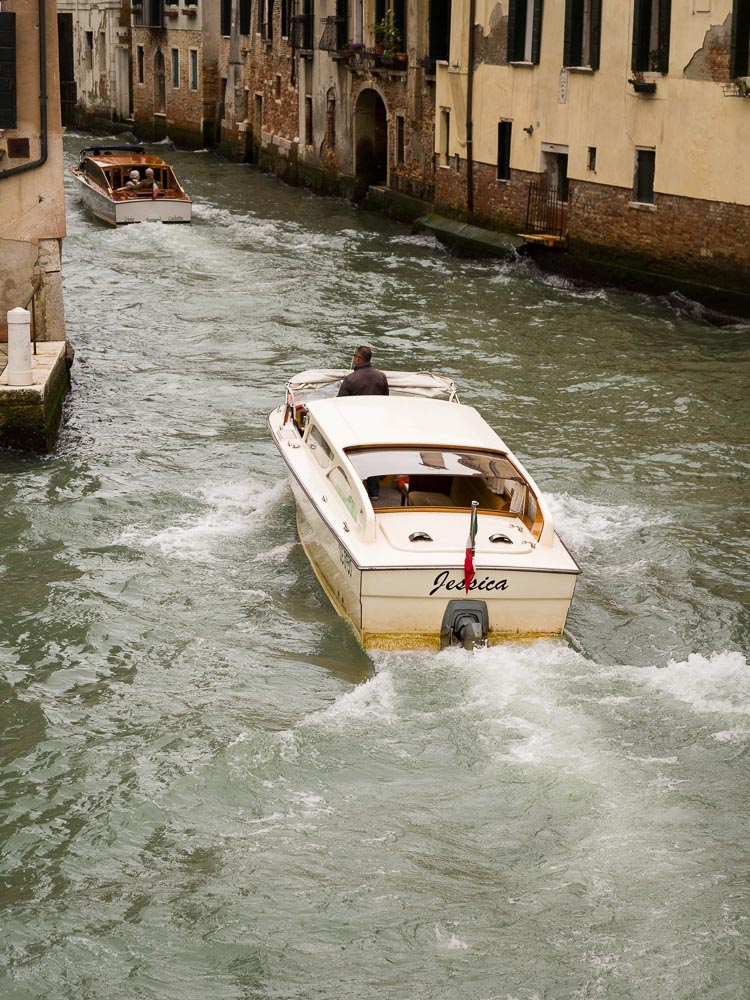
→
(220, 0, 450, 200)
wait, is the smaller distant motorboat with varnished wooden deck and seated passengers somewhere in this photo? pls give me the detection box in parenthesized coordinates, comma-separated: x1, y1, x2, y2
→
(70, 145, 193, 226)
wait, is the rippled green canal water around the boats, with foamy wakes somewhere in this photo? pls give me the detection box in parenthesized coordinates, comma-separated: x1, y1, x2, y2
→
(0, 136, 750, 1000)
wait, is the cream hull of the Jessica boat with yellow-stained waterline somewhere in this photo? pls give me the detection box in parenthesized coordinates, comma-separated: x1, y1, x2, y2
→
(290, 475, 577, 649)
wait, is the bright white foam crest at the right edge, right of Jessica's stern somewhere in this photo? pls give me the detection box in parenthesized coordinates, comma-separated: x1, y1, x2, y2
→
(638, 652, 750, 716)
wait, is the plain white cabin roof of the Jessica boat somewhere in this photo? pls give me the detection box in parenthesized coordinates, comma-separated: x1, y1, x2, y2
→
(307, 396, 508, 452)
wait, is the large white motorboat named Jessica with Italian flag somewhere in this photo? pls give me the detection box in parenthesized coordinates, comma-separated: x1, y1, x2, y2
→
(268, 370, 580, 649)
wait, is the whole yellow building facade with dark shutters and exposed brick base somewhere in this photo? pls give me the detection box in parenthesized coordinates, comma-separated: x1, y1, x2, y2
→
(435, 0, 750, 291)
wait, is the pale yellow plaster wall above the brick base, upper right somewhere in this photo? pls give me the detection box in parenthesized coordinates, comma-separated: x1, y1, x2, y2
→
(436, 0, 750, 205)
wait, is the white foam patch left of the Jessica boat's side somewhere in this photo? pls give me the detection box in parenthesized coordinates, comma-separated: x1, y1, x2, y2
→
(119, 480, 286, 561)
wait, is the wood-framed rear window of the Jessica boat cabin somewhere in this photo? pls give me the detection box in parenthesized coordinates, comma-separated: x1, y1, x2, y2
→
(347, 448, 533, 519)
